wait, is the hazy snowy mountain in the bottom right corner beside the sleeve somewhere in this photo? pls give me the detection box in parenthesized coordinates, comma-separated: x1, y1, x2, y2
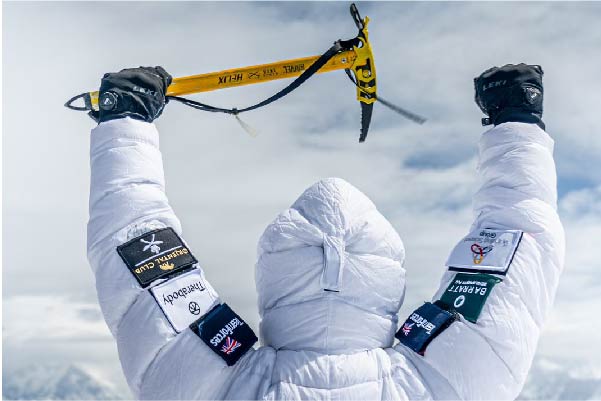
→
(518, 358, 601, 400)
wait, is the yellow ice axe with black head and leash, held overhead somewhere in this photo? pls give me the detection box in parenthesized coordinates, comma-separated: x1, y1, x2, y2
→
(65, 4, 425, 142)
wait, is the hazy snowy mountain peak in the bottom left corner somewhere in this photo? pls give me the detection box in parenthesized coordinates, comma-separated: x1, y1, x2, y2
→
(2, 364, 126, 400)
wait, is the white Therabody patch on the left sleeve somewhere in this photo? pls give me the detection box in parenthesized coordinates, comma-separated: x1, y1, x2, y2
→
(150, 269, 219, 333)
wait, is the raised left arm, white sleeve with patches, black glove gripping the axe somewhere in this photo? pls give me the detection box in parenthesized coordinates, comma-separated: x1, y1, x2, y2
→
(88, 68, 254, 399)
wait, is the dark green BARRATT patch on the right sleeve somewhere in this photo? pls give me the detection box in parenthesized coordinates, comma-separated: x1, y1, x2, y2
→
(440, 273, 502, 323)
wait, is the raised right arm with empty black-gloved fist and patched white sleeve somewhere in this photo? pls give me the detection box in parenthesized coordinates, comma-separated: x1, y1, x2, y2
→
(397, 65, 565, 399)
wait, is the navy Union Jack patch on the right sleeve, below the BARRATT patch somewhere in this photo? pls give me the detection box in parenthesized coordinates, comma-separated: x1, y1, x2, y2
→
(395, 302, 457, 355)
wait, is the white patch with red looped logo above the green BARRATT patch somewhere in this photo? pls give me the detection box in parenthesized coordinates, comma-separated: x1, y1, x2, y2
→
(446, 229, 523, 275)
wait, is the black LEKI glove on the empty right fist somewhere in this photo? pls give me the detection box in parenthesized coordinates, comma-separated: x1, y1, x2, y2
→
(474, 63, 545, 129)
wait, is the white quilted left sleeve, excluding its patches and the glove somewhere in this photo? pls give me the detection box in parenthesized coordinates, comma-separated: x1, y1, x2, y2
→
(88, 118, 237, 399)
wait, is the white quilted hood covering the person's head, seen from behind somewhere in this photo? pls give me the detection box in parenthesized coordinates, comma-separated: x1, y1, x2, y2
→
(255, 178, 405, 354)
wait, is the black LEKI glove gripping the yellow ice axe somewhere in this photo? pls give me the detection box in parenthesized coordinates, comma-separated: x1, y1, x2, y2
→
(89, 67, 172, 123)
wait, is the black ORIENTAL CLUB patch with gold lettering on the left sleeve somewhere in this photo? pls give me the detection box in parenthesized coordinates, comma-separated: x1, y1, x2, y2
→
(117, 228, 198, 288)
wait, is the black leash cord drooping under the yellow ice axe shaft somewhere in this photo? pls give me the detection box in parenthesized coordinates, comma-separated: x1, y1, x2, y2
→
(167, 39, 355, 115)
